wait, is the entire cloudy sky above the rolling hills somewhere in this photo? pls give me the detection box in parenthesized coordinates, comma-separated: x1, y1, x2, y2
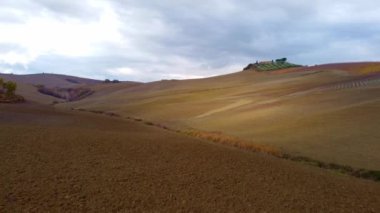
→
(0, 0, 380, 82)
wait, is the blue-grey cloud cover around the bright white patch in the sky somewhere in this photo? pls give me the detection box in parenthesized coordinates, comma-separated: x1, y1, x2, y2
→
(0, 0, 380, 81)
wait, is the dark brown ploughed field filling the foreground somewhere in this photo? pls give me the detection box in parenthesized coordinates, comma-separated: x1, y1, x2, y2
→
(0, 105, 380, 212)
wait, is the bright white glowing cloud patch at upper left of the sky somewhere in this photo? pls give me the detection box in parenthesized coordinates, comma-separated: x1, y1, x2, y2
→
(0, 2, 123, 65)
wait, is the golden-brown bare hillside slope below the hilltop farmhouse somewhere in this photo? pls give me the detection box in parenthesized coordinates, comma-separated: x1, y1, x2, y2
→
(62, 63, 380, 170)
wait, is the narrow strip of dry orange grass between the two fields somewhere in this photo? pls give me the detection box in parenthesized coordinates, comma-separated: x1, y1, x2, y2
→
(72, 108, 380, 181)
